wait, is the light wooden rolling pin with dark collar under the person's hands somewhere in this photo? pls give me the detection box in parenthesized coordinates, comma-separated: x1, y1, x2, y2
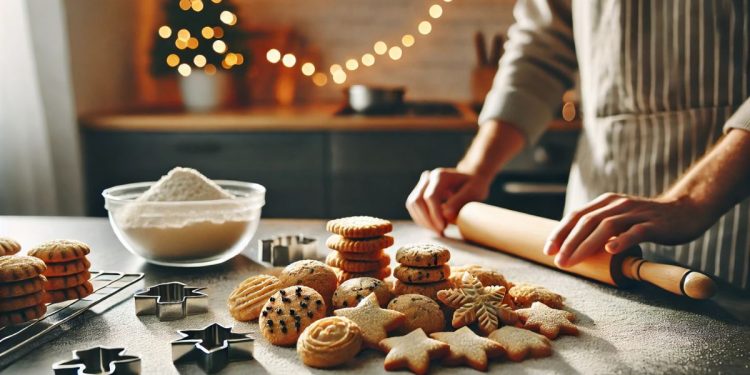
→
(456, 202, 716, 299)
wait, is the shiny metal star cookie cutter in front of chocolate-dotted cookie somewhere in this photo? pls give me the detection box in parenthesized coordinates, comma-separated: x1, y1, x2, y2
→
(172, 323, 254, 373)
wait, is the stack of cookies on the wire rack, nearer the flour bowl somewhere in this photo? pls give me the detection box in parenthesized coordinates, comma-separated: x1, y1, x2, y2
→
(29, 240, 94, 303)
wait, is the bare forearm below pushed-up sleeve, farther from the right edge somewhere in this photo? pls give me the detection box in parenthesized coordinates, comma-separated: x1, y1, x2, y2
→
(456, 120, 526, 182)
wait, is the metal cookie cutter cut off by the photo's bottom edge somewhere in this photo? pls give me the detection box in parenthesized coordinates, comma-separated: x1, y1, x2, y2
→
(52, 346, 141, 375)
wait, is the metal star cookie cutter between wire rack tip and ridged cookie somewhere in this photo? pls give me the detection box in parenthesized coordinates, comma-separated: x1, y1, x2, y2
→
(133, 281, 208, 321)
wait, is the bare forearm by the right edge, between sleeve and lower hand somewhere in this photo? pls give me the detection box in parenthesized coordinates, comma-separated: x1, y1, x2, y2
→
(661, 129, 750, 220)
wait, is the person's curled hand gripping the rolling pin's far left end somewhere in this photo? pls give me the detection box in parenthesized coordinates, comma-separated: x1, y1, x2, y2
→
(406, 168, 490, 235)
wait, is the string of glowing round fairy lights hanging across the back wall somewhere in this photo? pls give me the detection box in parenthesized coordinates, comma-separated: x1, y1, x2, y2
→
(266, 0, 453, 87)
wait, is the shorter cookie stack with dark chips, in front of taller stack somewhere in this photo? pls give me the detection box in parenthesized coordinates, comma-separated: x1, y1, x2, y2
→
(393, 243, 452, 300)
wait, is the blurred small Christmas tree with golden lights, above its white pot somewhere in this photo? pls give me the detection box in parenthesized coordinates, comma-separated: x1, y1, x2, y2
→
(151, 0, 247, 77)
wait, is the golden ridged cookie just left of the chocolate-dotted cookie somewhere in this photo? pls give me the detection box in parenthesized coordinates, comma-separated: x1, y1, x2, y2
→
(227, 275, 281, 322)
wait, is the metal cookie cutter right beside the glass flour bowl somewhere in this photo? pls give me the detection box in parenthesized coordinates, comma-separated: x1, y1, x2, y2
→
(258, 234, 318, 267)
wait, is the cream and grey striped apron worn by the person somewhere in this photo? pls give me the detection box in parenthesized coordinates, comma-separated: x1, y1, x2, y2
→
(566, 0, 750, 290)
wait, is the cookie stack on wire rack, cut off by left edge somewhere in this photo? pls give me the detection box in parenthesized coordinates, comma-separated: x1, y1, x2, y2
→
(0, 255, 47, 328)
